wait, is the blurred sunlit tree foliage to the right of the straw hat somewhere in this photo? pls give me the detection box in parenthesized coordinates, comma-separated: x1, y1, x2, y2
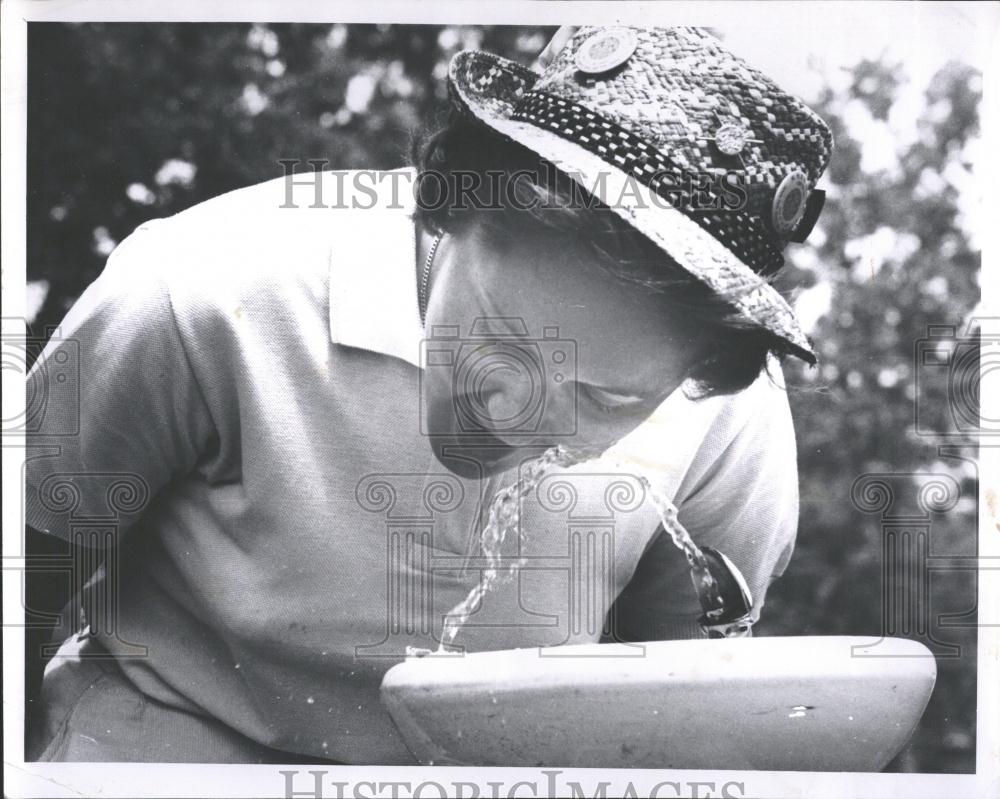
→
(761, 56, 981, 771)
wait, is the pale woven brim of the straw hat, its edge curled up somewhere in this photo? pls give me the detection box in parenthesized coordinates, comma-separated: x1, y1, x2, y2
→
(448, 50, 816, 364)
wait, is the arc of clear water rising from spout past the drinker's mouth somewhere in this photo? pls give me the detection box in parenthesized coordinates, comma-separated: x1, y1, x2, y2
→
(434, 446, 723, 656)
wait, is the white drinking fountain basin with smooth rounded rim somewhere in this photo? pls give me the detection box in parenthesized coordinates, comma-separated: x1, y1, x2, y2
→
(382, 636, 936, 771)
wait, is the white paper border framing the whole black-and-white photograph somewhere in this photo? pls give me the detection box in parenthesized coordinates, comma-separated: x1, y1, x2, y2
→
(0, 0, 1000, 799)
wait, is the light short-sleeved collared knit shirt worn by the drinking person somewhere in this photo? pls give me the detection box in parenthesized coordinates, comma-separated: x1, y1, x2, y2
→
(26, 167, 798, 763)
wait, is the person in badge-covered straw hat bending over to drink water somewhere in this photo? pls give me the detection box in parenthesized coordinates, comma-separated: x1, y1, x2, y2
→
(26, 28, 831, 763)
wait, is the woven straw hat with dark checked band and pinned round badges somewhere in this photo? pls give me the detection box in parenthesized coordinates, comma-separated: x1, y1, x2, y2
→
(448, 27, 833, 363)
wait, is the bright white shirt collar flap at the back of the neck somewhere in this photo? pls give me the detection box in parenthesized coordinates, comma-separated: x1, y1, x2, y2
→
(330, 168, 424, 368)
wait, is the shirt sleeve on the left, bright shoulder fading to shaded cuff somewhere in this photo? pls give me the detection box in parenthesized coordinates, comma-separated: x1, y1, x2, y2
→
(25, 220, 213, 539)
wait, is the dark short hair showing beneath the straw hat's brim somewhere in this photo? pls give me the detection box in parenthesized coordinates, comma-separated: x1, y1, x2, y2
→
(412, 111, 788, 398)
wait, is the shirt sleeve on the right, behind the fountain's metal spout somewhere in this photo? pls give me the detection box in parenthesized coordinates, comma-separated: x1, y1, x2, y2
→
(604, 374, 799, 640)
